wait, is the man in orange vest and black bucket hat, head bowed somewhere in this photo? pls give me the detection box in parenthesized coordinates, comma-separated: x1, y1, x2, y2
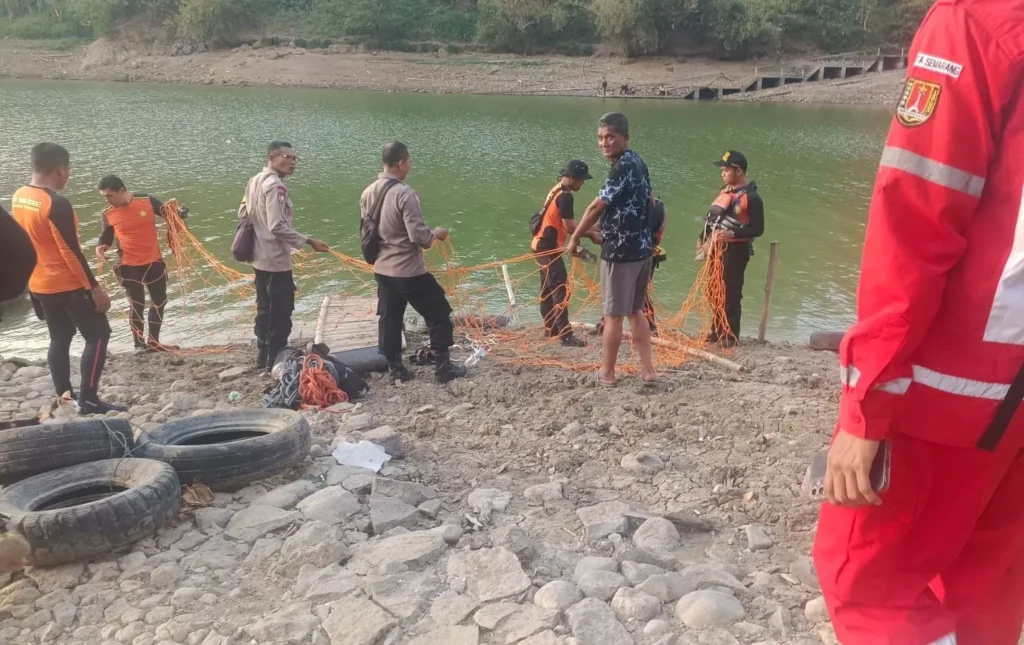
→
(529, 159, 594, 347)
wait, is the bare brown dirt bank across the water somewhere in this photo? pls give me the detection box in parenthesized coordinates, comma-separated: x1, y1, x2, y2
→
(0, 40, 899, 104)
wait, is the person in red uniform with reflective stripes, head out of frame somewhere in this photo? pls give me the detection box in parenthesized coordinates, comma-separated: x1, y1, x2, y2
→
(814, 0, 1024, 645)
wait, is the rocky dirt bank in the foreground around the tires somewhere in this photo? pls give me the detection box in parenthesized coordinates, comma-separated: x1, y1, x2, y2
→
(0, 337, 838, 645)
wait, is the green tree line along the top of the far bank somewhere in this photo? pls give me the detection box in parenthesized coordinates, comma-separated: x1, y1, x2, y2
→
(0, 0, 931, 59)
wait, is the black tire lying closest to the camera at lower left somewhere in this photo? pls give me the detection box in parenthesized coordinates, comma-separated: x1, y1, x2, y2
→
(0, 459, 181, 565)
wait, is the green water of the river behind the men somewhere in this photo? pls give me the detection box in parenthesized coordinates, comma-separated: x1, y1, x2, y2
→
(0, 83, 889, 353)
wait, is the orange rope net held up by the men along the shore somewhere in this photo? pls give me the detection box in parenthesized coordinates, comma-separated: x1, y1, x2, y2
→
(94, 200, 728, 373)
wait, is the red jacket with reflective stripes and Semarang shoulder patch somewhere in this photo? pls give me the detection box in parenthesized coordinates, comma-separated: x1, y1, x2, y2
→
(839, 0, 1024, 446)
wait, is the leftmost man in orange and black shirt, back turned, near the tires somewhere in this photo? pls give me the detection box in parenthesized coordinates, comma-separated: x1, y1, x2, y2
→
(11, 143, 126, 415)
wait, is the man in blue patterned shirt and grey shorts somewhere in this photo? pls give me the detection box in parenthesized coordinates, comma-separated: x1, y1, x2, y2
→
(566, 113, 657, 385)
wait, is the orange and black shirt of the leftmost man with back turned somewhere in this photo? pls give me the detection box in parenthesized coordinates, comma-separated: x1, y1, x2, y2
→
(11, 186, 92, 294)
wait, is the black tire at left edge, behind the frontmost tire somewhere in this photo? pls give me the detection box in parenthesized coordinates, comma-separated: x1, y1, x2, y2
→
(0, 419, 135, 485)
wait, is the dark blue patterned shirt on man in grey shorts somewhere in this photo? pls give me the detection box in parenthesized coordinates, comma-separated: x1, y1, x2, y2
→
(597, 151, 654, 262)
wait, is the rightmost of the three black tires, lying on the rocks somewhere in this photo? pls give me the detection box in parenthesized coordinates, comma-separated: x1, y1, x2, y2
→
(134, 409, 312, 490)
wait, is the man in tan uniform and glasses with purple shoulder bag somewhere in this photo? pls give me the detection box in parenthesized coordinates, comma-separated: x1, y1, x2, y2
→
(239, 141, 330, 371)
